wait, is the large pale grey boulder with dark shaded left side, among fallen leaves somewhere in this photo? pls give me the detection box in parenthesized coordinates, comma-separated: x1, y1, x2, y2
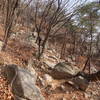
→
(6, 65, 44, 100)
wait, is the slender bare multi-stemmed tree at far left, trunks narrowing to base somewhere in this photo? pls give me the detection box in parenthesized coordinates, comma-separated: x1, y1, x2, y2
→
(2, 0, 19, 50)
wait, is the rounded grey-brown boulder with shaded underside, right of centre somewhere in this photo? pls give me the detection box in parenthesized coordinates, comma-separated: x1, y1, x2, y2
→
(51, 62, 80, 79)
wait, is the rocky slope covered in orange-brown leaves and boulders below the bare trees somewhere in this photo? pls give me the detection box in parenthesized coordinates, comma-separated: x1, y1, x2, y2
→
(0, 24, 100, 100)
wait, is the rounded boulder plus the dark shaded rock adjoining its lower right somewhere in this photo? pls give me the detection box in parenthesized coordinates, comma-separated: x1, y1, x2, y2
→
(45, 62, 89, 91)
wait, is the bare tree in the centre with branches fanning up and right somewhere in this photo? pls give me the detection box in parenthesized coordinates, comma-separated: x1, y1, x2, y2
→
(35, 0, 78, 58)
